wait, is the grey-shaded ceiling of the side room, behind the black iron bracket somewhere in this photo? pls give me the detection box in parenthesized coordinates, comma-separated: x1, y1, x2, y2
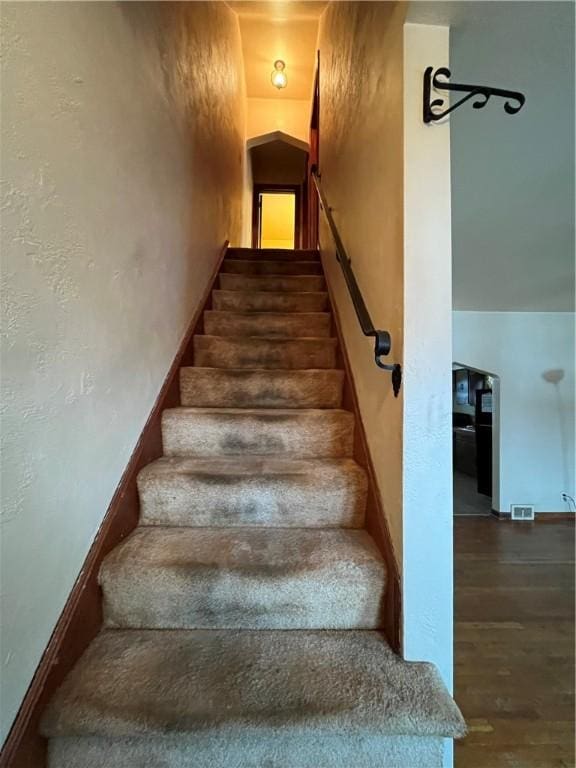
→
(452, 0, 575, 312)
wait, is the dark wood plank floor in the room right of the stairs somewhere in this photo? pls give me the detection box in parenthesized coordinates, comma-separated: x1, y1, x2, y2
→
(454, 517, 575, 768)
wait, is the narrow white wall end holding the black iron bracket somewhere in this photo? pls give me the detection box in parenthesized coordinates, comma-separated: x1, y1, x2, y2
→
(402, 24, 453, 765)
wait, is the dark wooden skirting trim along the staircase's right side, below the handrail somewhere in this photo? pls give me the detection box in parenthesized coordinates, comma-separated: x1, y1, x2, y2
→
(324, 260, 402, 655)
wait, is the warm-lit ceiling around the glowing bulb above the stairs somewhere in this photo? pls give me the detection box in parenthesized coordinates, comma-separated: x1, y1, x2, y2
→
(228, 0, 327, 99)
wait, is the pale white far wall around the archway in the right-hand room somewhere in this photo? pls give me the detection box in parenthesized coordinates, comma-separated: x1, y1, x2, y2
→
(453, 312, 575, 512)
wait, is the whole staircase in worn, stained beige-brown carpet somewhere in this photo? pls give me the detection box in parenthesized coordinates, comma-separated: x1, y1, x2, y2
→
(42, 249, 464, 768)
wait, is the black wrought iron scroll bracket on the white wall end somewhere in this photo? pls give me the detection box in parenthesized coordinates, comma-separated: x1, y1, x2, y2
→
(423, 67, 526, 123)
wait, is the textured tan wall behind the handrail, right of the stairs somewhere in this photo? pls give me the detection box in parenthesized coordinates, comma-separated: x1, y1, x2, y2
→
(319, 2, 405, 559)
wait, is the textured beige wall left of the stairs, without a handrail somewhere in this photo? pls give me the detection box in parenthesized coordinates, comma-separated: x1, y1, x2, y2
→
(0, 2, 245, 738)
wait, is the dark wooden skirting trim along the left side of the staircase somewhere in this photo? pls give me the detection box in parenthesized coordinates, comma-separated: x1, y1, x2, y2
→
(0, 240, 229, 768)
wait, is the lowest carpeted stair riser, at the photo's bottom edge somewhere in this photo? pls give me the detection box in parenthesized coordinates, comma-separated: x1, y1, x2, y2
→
(48, 736, 444, 768)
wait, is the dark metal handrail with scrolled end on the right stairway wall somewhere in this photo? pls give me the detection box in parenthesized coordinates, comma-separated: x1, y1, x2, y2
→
(311, 168, 402, 397)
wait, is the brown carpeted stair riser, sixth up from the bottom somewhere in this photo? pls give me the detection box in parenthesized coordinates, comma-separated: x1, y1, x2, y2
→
(194, 336, 336, 370)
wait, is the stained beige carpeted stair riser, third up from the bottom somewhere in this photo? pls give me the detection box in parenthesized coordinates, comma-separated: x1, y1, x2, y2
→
(138, 471, 366, 528)
